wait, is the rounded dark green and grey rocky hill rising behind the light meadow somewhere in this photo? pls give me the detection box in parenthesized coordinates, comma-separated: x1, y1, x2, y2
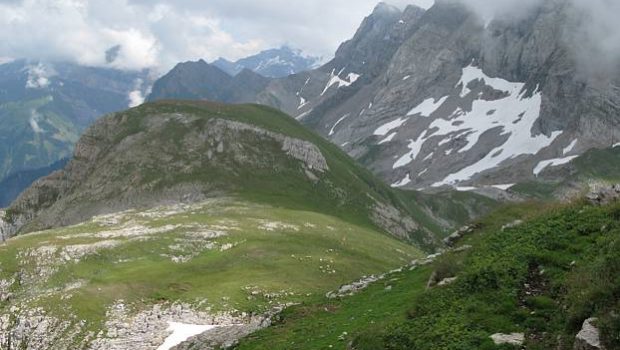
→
(1, 101, 490, 247)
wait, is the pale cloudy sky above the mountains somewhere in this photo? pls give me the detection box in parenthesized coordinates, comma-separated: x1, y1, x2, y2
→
(0, 0, 433, 70)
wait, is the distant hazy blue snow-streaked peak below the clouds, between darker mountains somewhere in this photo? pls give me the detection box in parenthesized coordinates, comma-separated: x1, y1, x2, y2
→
(212, 46, 320, 78)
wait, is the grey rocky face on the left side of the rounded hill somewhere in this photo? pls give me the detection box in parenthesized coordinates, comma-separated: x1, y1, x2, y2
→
(2, 106, 329, 236)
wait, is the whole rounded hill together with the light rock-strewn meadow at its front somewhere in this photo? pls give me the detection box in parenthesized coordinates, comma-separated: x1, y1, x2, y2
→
(0, 101, 496, 349)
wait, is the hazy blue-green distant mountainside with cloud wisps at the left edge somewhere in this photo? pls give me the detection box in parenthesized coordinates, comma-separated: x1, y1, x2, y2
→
(0, 60, 148, 198)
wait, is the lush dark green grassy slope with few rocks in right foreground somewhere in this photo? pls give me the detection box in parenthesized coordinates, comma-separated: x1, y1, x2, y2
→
(239, 203, 620, 350)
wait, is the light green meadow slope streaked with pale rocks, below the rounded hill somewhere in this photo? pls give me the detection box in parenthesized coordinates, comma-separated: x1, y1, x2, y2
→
(0, 199, 421, 331)
